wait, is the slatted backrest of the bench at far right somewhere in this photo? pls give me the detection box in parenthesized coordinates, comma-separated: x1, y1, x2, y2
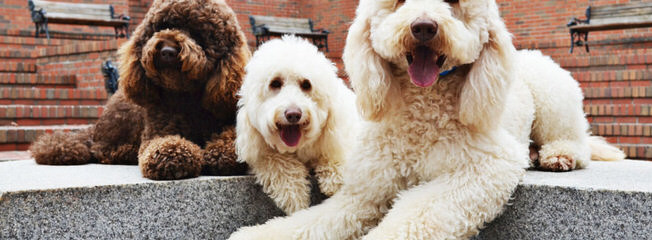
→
(590, 2, 652, 24)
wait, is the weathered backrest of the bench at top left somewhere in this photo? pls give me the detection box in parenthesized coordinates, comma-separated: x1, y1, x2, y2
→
(32, 0, 113, 21)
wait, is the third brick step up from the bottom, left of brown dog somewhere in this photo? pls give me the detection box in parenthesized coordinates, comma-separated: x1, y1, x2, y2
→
(0, 87, 107, 105)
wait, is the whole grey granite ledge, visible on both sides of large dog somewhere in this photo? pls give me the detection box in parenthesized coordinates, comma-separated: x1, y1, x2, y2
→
(0, 160, 652, 239)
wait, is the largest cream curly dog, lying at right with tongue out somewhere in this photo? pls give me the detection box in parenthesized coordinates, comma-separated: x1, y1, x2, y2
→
(231, 0, 623, 239)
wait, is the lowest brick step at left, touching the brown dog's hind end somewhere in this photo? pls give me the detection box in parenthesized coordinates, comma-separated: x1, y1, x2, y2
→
(0, 124, 91, 151)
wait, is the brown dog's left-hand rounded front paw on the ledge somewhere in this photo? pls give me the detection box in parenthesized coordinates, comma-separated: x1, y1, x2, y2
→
(138, 136, 201, 180)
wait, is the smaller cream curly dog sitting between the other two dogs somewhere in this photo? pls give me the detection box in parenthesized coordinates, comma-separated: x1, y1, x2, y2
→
(236, 36, 360, 214)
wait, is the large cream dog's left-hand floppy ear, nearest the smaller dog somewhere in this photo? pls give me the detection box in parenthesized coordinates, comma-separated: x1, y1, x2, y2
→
(342, 9, 392, 121)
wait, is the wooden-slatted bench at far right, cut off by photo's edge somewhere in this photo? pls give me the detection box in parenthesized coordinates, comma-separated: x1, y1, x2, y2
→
(566, 2, 652, 53)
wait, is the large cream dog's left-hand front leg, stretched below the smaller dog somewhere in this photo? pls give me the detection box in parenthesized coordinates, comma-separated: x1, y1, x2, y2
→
(229, 145, 406, 240)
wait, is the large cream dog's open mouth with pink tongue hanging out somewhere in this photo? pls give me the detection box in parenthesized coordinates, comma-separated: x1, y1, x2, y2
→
(405, 45, 446, 88)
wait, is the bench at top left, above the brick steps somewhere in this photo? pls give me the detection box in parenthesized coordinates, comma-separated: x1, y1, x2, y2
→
(28, 0, 130, 40)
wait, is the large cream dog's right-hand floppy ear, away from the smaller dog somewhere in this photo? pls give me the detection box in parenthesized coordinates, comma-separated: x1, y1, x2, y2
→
(460, 9, 516, 131)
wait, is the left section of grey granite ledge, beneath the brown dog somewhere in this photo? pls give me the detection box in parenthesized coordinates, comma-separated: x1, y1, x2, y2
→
(0, 160, 282, 239)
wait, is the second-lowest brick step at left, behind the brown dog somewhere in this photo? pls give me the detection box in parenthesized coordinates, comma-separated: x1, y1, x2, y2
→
(0, 105, 104, 126)
